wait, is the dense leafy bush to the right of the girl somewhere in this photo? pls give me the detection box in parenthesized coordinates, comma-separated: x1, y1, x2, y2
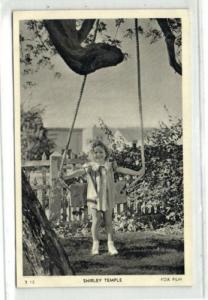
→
(98, 116, 183, 231)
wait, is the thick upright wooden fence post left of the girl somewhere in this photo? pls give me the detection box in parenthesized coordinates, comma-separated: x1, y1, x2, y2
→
(49, 152, 63, 223)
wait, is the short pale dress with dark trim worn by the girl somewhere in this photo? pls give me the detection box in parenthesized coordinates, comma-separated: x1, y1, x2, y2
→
(83, 161, 116, 211)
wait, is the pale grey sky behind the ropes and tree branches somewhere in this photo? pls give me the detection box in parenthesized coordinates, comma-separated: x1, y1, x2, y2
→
(21, 19, 182, 128)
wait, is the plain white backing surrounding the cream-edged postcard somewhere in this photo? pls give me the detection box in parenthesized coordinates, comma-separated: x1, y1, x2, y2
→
(1, 0, 203, 300)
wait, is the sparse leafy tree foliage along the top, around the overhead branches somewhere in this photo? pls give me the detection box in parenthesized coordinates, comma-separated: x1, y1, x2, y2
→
(19, 18, 182, 88)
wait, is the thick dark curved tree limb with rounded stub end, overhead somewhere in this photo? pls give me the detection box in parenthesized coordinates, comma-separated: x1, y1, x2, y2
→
(44, 20, 124, 75)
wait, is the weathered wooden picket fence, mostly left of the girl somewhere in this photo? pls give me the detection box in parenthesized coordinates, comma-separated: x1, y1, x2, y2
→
(22, 152, 127, 223)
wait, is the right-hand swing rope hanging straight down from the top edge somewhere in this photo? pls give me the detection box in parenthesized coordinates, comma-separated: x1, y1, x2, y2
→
(128, 19, 145, 191)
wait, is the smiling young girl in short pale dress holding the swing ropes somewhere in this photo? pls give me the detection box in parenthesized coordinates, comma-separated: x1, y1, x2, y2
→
(63, 141, 144, 255)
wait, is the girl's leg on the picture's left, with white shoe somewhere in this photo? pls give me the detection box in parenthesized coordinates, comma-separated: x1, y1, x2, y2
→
(91, 209, 101, 255)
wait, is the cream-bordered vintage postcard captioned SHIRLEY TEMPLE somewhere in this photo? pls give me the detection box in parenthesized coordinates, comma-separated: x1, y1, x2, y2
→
(13, 10, 192, 287)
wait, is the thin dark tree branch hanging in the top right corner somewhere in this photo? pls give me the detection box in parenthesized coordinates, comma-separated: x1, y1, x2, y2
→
(157, 19, 182, 75)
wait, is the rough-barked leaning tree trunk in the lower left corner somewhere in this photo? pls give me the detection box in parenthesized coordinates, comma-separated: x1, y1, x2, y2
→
(22, 172, 75, 276)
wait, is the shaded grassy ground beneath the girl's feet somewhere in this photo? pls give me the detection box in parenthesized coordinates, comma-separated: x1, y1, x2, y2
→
(62, 231, 184, 275)
